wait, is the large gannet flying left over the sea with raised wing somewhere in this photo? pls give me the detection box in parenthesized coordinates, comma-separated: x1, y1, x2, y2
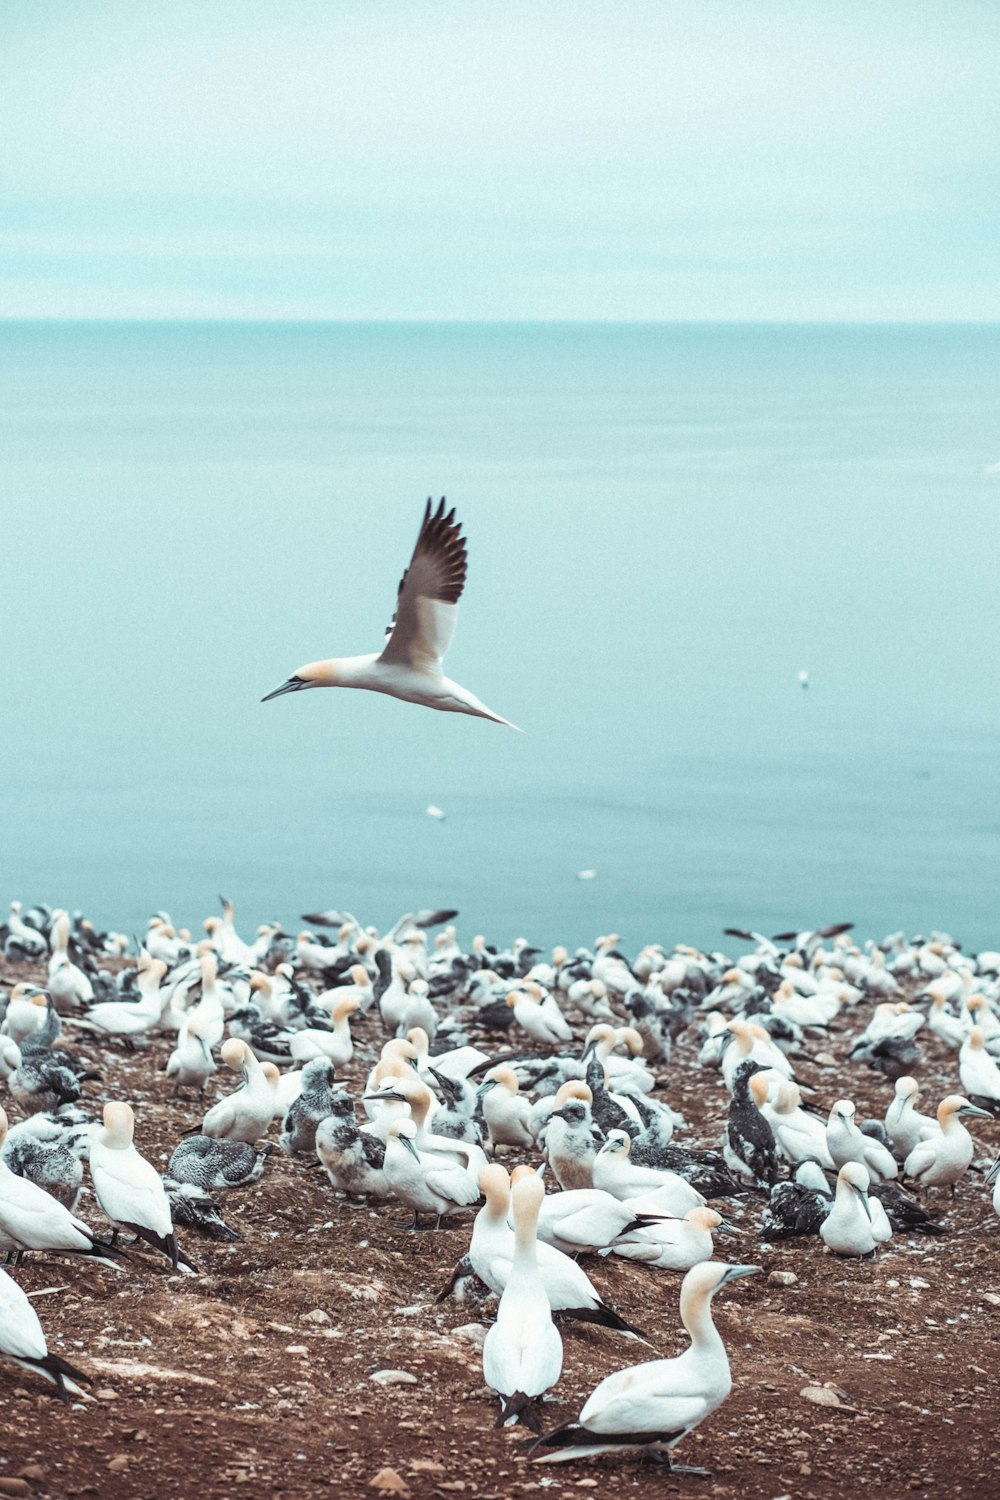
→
(261, 500, 517, 729)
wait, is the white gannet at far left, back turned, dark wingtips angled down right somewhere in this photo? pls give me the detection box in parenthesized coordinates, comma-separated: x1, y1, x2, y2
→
(90, 1103, 196, 1274)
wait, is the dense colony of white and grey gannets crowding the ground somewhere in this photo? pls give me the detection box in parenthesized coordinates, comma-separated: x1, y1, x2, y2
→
(0, 900, 1000, 1488)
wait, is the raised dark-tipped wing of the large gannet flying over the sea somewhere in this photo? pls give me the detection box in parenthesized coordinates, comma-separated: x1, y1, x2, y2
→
(381, 498, 466, 672)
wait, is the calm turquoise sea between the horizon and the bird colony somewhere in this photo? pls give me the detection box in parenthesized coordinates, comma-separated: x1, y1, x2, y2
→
(0, 324, 1000, 948)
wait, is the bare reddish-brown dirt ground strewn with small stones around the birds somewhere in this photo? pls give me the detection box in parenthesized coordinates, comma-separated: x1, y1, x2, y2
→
(0, 948, 1000, 1500)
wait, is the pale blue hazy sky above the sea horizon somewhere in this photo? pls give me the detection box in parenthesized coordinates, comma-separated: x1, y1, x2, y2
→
(0, 0, 1000, 321)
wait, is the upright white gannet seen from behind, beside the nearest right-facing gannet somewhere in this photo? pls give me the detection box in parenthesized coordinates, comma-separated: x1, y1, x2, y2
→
(483, 1173, 562, 1433)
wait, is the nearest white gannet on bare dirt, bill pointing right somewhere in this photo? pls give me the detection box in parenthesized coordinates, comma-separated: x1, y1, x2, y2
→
(528, 1262, 760, 1475)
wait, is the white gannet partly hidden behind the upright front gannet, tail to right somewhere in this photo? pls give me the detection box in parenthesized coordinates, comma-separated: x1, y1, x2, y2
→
(469, 1163, 643, 1338)
